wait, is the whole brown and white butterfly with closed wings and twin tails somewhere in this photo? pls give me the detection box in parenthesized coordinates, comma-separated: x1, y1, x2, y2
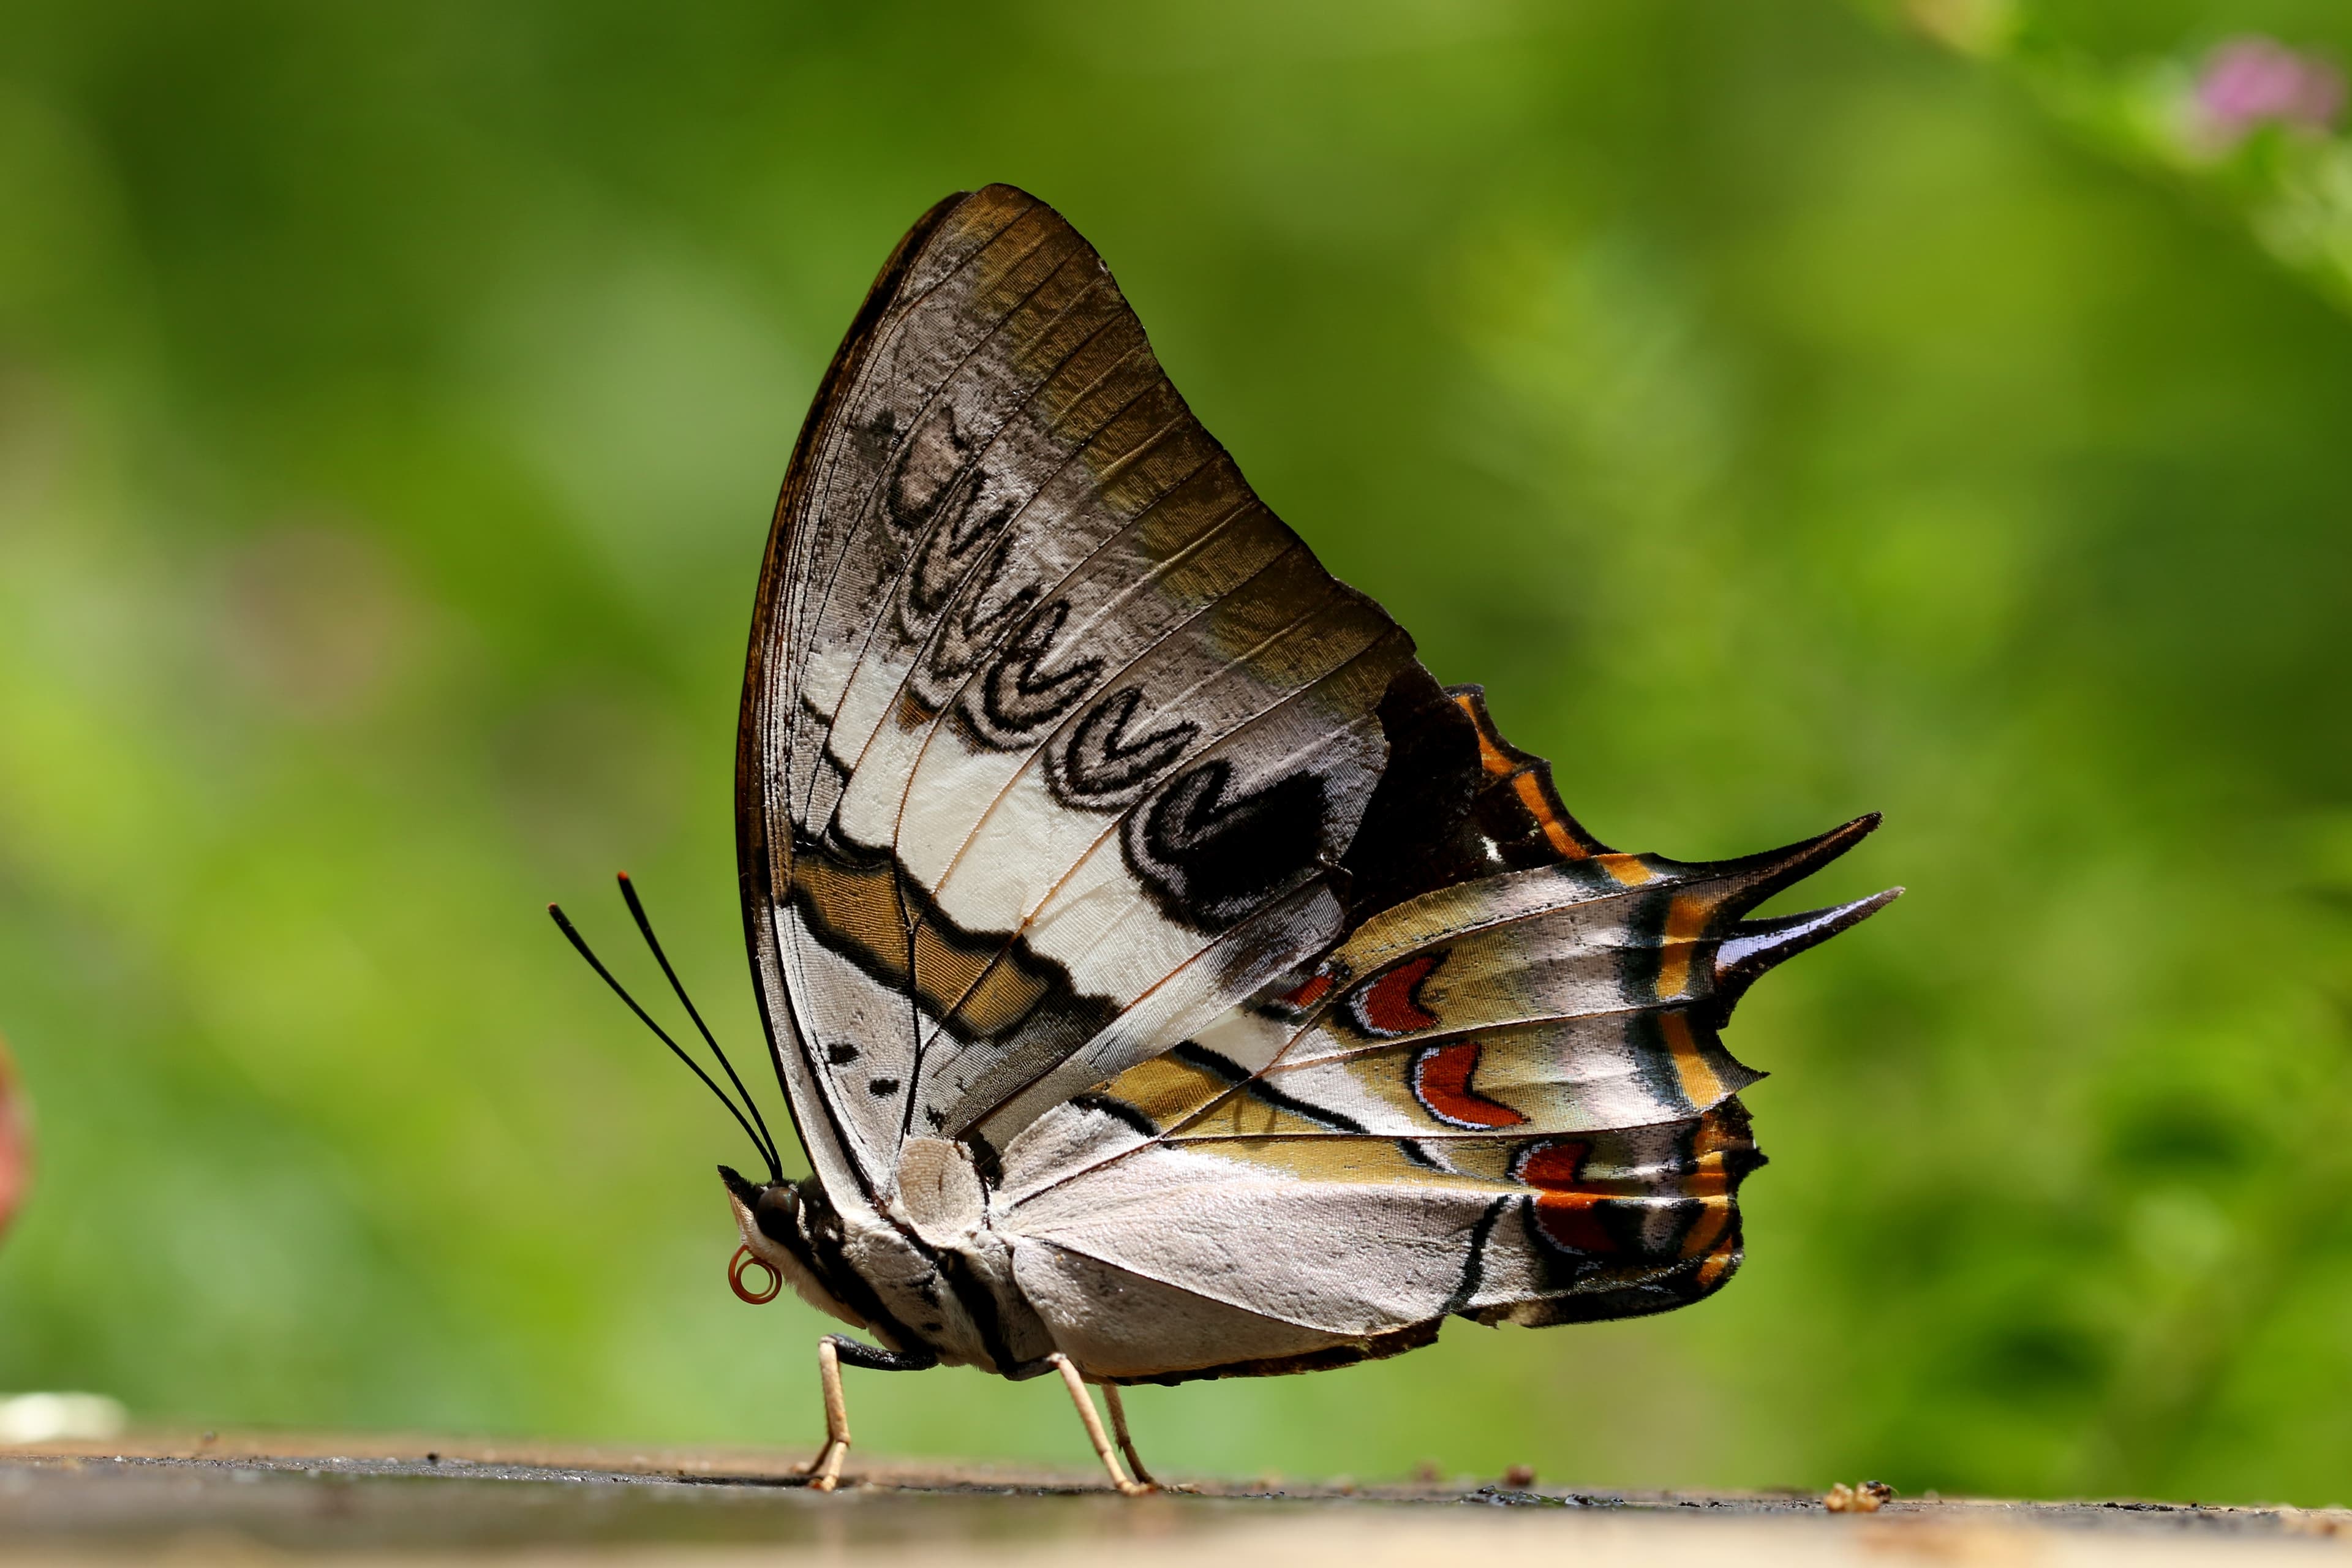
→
(557, 186, 1901, 1490)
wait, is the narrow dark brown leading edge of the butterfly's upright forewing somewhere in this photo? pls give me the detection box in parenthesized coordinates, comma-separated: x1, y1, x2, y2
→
(736, 190, 971, 1194)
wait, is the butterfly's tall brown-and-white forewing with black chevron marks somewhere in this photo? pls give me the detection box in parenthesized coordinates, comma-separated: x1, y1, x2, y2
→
(743, 188, 1411, 1189)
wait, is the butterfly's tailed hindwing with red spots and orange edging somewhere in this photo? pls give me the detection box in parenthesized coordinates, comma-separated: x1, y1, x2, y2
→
(973, 724, 1884, 1375)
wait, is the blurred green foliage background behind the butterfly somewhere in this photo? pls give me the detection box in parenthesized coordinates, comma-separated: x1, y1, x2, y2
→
(0, 0, 2352, 1504)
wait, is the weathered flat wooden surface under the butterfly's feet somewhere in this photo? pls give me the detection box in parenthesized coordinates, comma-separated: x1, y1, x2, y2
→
(0, 1434, 2352, 1568)
